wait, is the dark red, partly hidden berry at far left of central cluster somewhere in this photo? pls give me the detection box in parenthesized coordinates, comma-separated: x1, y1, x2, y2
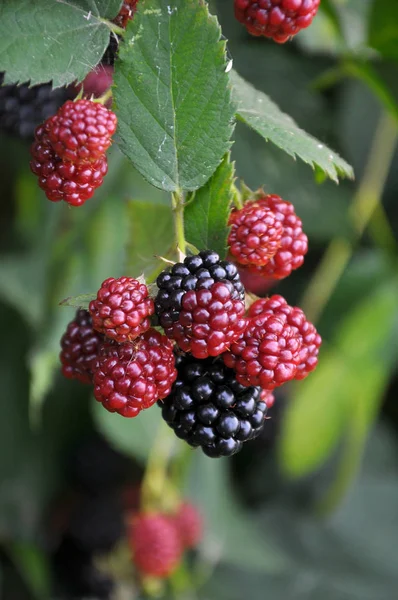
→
(60, 310, 103, 383)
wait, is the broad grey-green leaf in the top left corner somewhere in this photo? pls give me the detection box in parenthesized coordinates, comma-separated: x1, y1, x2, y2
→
(0, 0, 121, 87)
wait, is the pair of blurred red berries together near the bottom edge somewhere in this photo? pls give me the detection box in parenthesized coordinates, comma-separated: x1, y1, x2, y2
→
(128, 502, 203, 579)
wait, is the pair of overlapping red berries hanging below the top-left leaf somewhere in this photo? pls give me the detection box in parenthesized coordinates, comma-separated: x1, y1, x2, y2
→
(30, 99, 117, 206)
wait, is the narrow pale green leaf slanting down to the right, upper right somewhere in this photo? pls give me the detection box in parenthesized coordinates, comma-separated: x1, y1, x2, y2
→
(231, 72, 354, 182)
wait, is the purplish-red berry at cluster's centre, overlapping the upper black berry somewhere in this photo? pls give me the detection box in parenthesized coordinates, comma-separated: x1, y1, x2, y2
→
(166, 282, 247, 358)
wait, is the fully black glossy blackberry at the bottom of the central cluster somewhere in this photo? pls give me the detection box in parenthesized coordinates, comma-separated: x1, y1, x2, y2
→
(158, 354, 267, 458)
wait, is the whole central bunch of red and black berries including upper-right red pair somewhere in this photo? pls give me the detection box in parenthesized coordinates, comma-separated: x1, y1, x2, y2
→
(61, 196, 321, 457)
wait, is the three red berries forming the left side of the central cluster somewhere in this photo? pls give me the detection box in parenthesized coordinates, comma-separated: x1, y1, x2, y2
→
(61, 277, 177, 417)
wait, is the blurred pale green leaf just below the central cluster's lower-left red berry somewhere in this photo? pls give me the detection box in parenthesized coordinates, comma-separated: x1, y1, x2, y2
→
(93, 400, 161, 463)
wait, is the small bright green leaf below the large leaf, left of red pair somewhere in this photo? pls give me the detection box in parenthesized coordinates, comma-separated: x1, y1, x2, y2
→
(184, 154, 234, 257)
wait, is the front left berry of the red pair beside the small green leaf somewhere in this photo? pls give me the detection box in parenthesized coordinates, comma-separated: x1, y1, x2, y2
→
(228, 201, 283, 266)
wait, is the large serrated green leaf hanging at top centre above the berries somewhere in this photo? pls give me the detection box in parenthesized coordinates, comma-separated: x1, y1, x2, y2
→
(114, 0, 234, 191)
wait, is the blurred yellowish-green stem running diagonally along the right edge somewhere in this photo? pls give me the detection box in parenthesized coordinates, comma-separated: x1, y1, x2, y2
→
(301, 112, 398, 321)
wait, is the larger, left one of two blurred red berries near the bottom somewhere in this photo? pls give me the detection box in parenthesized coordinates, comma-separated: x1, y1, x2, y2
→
(128, 513, 183, 579)
